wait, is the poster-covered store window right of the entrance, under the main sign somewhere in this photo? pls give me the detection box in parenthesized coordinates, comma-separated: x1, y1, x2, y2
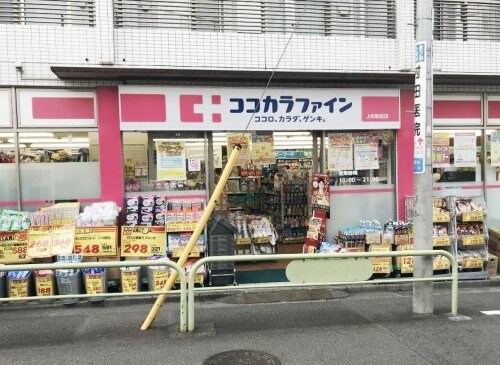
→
(325, 131, 394, 186)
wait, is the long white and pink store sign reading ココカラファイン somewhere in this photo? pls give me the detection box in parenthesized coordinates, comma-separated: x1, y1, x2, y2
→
(119, 85, 400, 131)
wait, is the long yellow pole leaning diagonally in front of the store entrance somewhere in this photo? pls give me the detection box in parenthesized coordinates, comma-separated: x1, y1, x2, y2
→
(141, 144, 241, 331)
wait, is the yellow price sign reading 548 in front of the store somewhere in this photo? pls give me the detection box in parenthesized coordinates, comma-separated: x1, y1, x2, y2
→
(74, 226, 118, 256)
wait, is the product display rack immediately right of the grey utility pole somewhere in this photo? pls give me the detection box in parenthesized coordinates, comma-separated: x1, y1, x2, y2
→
(432, 197, 456, 273)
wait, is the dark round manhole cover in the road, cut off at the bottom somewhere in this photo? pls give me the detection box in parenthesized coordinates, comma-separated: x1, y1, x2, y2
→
(203, 350, 281, 365)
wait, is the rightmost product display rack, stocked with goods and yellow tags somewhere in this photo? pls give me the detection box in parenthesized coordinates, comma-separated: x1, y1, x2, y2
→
(451, 196, 488, 278)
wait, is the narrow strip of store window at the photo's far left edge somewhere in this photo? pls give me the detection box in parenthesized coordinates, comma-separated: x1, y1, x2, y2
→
(0, 132, 17, 210)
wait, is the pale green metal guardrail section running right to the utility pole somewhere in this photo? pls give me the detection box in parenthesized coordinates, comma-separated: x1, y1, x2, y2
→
(188, 250, 458, 331)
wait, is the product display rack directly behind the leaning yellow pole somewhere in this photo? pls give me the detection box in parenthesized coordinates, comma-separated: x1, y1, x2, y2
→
(165, 199, 207, 285)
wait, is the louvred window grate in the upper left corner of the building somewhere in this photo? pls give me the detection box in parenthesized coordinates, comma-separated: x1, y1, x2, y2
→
(0, 0, 96, 27)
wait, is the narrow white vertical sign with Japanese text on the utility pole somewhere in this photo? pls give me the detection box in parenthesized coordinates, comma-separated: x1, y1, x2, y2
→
(413, 42, 427, 174)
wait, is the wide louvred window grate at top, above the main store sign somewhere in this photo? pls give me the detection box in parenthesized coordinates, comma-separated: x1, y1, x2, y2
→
(114, 0, 396, 38)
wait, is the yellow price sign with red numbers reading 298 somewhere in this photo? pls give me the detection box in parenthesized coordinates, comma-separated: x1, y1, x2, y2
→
(121, 227, 167, 257)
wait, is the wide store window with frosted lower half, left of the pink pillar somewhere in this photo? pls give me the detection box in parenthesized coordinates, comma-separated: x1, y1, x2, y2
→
(19, 131, 101, 211)
